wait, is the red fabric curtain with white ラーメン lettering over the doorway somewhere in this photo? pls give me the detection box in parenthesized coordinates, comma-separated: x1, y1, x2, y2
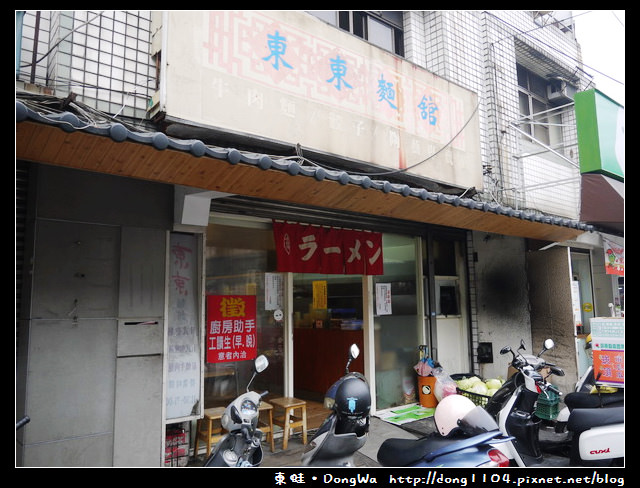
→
(273, 222, 383, 275)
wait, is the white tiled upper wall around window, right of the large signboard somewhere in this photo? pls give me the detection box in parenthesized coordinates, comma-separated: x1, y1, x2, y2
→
(405, 10, 584, 218)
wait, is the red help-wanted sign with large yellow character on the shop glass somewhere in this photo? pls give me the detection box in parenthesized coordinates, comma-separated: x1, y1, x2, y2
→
(207, 295, 258, 363)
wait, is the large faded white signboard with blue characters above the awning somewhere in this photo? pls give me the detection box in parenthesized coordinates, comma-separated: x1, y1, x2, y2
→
(160, 10, 483, 188)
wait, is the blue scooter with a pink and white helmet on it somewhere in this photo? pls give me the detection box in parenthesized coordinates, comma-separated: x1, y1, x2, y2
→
(377, 394, 513, 467)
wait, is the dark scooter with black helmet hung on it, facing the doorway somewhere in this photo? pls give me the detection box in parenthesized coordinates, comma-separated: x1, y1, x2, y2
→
(302, 344, 371, 467)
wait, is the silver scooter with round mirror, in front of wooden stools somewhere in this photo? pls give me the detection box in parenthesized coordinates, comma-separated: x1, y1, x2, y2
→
(203, 355, 269, 468)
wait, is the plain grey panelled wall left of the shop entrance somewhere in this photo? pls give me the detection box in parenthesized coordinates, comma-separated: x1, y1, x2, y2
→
(16, 165, 173, 466)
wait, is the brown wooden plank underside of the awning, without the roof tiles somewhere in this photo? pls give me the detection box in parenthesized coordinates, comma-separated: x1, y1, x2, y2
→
(16, 121, 584, 242)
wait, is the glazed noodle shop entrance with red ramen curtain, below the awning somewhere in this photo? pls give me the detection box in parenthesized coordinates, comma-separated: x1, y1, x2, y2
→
(204, 202, 471, 409)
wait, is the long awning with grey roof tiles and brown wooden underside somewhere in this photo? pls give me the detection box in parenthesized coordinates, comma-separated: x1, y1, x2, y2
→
(16, 100, 592, 242)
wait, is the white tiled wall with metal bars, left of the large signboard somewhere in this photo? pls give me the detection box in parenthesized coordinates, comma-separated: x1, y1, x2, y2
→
(19, 10, 156, 118)
